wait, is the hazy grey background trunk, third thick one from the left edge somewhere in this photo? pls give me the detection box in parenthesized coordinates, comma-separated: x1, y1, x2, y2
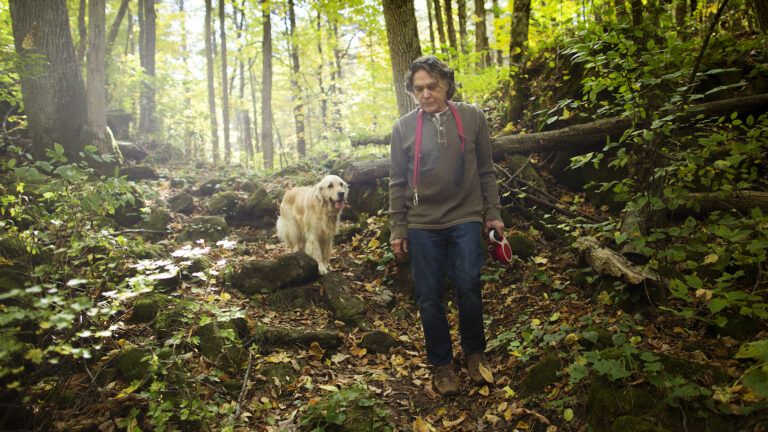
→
(139, 0, 157, 140)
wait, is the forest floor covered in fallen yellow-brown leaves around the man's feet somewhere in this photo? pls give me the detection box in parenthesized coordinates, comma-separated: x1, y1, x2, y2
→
(45, 166, 765, 432)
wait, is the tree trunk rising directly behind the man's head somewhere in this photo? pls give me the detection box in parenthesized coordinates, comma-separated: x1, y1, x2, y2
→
(383, 0, 421, 116)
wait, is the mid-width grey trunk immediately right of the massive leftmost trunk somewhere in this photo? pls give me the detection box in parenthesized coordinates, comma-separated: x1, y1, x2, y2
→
(85, 0, 113, 154)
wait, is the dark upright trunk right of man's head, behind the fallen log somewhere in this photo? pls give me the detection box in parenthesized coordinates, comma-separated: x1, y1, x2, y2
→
(506, 0, 531, 121)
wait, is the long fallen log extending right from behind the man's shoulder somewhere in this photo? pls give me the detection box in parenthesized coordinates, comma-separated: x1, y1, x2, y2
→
(492, 94, 768, 160)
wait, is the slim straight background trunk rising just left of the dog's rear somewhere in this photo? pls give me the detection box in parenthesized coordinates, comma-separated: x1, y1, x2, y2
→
(261, 0, 275, 170)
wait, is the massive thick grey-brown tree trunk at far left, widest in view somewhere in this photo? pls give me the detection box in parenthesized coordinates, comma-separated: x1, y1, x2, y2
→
(9, 0, 88, 160)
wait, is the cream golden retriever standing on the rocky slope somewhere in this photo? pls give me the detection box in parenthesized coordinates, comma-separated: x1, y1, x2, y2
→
(277, 175, 349, 274)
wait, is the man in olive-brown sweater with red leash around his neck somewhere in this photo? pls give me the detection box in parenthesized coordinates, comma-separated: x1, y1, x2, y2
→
(389, 56, 504, 396)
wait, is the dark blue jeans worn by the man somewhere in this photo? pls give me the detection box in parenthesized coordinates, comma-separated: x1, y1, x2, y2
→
(408, 222, 485, 366)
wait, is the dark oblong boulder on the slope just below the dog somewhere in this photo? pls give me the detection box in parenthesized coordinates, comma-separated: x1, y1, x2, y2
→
(232, 251, 320, 295)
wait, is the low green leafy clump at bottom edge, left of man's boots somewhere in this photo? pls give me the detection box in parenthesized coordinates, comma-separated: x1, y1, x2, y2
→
(301, 384, 394, 432)
